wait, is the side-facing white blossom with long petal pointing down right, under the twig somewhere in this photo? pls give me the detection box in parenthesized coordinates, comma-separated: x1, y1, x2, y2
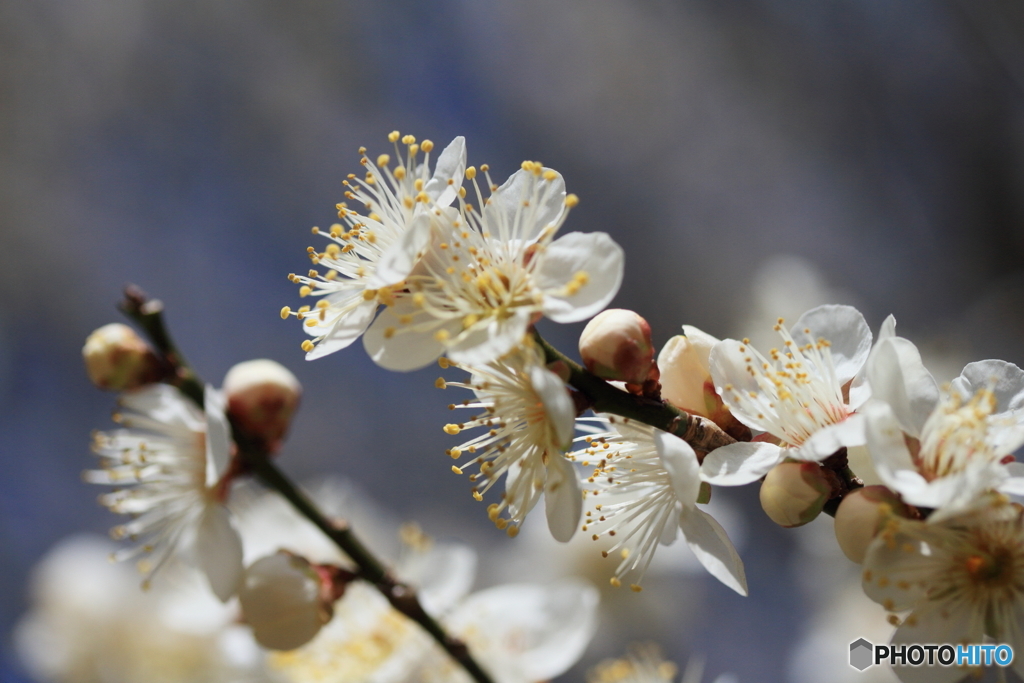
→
(571, 417, 746, 595)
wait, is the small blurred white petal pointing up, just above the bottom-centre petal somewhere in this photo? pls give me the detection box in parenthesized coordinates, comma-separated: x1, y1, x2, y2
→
(395, 543, 476, 616)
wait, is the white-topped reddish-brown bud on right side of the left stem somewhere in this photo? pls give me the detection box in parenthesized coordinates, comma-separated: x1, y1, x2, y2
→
(223, 359, 302, 452)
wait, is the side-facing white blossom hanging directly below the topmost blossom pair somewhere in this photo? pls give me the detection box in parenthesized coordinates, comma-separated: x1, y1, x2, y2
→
(437, 340, 583, 542)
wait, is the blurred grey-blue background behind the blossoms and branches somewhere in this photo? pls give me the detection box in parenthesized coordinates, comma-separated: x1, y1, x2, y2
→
(0, 0, 1024, 683)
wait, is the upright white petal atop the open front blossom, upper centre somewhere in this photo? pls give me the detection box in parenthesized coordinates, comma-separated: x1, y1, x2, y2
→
(482, 168, 565, 242)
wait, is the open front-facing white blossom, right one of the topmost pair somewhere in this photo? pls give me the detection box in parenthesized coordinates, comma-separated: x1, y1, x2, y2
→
(364, 162, 623, 371)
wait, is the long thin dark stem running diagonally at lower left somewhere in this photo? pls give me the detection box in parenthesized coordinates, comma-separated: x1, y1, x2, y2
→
(119, 285, 493, 683)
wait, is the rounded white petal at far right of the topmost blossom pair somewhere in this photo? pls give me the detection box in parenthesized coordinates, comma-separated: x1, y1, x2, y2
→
(536, 232, 624, 323)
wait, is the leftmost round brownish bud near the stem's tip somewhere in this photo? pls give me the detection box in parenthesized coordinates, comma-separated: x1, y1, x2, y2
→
(82, 323, 160, 391)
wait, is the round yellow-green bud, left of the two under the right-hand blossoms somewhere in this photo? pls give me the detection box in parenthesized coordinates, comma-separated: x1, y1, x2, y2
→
(761, 462, 831, 526)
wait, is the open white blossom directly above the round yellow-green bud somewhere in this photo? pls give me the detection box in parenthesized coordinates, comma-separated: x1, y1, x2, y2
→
(701, 305, 871, 486)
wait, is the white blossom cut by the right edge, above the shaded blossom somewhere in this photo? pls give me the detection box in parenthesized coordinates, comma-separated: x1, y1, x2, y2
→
(862, 335, 1024, 521)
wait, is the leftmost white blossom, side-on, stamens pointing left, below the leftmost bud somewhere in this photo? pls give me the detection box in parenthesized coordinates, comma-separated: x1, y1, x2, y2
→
(83, 384, 243, 600)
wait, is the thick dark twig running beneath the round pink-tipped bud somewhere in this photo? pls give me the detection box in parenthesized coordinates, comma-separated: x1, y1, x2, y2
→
(534, 329, 736, 457)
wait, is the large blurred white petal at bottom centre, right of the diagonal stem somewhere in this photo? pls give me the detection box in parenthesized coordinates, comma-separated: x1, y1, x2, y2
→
(449, 580, 599, 681)
